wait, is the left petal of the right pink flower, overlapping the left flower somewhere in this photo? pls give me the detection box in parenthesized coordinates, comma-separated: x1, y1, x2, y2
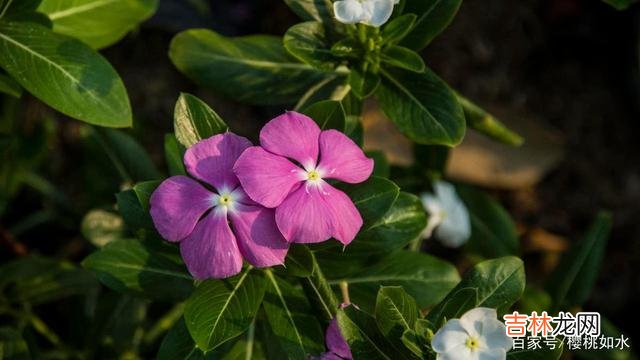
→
(233, 146, 304, 208)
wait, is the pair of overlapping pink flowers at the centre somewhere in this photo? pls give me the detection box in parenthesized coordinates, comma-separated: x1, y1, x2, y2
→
(150, 112, 373, 279)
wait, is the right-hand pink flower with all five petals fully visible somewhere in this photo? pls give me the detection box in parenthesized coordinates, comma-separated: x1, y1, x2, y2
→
(233, 112, 373, 245)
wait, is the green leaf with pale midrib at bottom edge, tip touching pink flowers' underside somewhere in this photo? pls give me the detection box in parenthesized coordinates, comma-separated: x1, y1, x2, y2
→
(262, 270, 324, 359)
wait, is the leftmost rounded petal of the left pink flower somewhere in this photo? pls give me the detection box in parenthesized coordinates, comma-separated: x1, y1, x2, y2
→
(149, 176, 216, 242)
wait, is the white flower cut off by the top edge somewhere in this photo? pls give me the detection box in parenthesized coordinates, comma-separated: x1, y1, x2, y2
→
(333, 0, 400, 27)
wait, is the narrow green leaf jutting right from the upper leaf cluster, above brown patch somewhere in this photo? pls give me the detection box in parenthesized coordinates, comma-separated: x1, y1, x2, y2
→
(458, 95, 524, 146)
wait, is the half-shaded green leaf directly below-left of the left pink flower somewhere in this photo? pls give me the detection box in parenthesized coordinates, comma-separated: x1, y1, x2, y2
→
(82, 239, 193, 300)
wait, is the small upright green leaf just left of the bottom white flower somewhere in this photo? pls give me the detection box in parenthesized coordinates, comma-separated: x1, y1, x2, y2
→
(375, 286, 418, 358)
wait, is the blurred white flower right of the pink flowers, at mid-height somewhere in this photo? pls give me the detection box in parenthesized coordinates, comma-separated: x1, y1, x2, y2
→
(422, 181, 471, 247)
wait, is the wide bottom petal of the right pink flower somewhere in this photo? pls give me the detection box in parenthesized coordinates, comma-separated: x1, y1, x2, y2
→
(276, 181, 362, 245)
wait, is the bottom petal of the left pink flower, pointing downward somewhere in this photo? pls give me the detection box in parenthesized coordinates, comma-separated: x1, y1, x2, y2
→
(180, 209, 242, 279)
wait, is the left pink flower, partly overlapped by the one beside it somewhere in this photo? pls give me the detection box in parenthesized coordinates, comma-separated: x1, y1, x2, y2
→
(150, 133, 288, 279)
